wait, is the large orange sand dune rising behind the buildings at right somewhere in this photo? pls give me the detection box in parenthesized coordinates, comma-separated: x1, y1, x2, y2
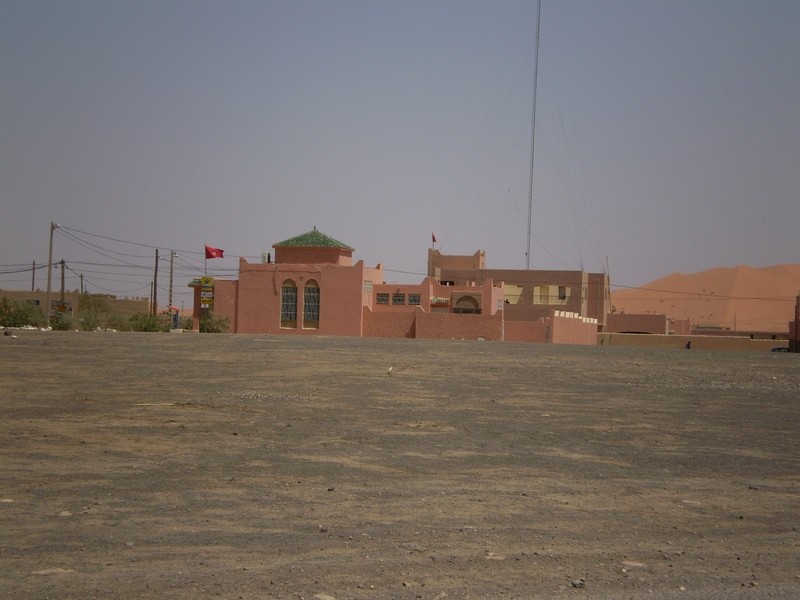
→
(611, 264, 800, 332)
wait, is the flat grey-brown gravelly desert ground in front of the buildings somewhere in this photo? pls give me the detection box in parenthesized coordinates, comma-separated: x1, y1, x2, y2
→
(0, 331, 800, 600)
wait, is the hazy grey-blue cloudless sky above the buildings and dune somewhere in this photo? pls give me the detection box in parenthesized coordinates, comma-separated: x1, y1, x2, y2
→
(0, 0, 800, 305)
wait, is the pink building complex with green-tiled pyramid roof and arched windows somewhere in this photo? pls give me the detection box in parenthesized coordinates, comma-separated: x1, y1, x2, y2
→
(193, 228, 607, 344)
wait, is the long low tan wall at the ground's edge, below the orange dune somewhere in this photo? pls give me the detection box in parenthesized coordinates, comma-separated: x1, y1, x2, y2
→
(597, 333, 789, 352)
